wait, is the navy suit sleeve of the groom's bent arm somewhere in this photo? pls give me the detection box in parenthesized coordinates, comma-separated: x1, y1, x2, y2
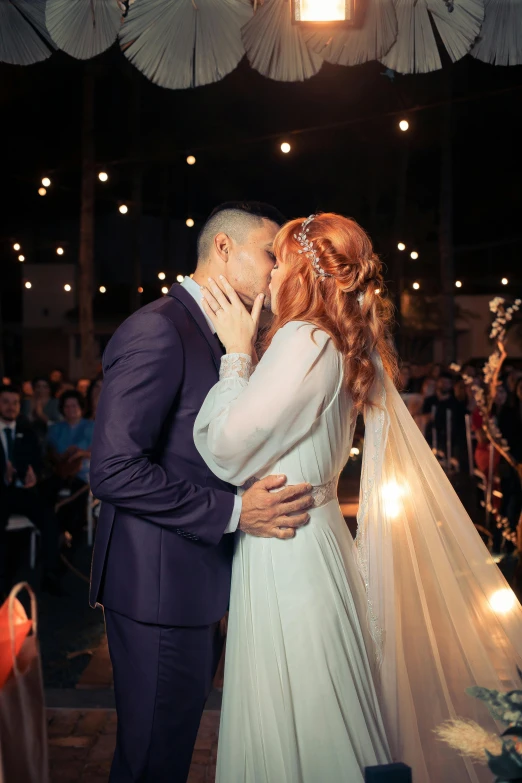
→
(91, 312, 234, 545)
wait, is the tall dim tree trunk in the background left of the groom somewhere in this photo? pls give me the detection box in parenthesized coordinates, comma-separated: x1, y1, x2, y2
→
(78, 63, 96, 378)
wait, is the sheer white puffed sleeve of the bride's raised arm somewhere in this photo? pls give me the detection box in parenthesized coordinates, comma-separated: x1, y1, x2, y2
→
(194, 321, 339, 486)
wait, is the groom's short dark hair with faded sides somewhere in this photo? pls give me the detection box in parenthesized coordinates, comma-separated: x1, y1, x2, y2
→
(198, 201, 286, 263)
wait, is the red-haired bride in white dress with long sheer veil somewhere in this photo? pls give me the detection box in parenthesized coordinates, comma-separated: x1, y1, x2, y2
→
(194, 214, 522, 783)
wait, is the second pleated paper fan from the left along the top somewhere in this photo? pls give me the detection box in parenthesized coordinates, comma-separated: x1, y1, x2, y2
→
(45, 0, 122, 60)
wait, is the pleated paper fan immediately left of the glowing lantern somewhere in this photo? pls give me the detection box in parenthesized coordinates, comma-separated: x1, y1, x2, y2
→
(243, 0, 323, 82)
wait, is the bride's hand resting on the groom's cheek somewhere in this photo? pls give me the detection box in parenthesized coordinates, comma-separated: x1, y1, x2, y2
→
(202, 276, 265, 356)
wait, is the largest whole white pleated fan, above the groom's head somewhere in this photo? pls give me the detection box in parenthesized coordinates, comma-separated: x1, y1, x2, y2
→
(120, 0, 253, 90)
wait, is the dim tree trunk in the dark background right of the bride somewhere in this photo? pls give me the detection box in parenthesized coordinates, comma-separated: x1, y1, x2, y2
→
(439, 72, 456, 364)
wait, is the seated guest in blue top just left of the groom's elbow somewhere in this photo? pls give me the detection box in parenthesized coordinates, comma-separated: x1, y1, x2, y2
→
(47, 391, 94, 534)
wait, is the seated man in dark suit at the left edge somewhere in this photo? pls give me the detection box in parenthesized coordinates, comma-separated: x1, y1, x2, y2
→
(0, 386, 60, 594)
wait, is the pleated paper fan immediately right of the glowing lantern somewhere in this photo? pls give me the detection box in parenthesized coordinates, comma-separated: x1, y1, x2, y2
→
(305, 0, 397, 65)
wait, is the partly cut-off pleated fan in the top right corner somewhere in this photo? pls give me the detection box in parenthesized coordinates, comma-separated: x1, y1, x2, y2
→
(471, 0, 522, 65)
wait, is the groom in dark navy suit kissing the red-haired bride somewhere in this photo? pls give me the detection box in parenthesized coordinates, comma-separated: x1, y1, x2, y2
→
(90, 203, 312, 783)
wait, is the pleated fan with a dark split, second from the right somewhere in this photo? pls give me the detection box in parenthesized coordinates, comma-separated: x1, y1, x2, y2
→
(381, 0, 484, 73)
